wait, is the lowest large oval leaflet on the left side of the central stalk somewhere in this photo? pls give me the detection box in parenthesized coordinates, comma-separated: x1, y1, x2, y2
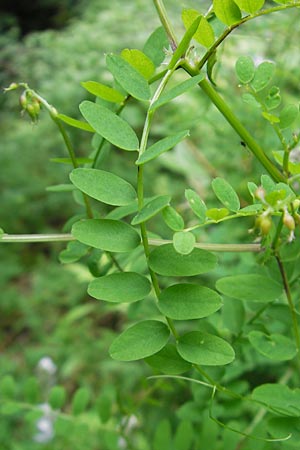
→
(109, 320, 170, 361)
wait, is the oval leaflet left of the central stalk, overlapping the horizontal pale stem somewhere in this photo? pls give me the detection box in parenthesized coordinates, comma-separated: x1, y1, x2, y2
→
(72, 219, 140, 252)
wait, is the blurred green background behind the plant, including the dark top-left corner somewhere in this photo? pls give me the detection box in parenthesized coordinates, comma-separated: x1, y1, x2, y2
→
(0, 0, 300, 450)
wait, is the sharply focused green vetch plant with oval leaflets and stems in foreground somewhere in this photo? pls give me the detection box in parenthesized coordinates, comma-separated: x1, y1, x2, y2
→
(1, 0, 300, 450)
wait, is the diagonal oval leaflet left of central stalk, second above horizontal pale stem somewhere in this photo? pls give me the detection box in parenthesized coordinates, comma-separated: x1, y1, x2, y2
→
(79, 100, 139, 151)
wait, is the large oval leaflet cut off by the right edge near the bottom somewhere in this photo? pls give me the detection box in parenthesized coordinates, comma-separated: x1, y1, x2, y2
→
(252, 383, 300, 417)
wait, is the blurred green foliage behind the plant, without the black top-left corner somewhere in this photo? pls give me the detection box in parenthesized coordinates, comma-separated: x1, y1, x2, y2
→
(0, 0, 300, 450)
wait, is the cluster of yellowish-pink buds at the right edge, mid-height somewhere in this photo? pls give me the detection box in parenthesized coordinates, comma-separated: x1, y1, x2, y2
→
(255, 186, 300, 242)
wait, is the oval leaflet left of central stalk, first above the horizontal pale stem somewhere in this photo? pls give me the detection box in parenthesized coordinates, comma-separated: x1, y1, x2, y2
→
(70, 168, 136, 206)
